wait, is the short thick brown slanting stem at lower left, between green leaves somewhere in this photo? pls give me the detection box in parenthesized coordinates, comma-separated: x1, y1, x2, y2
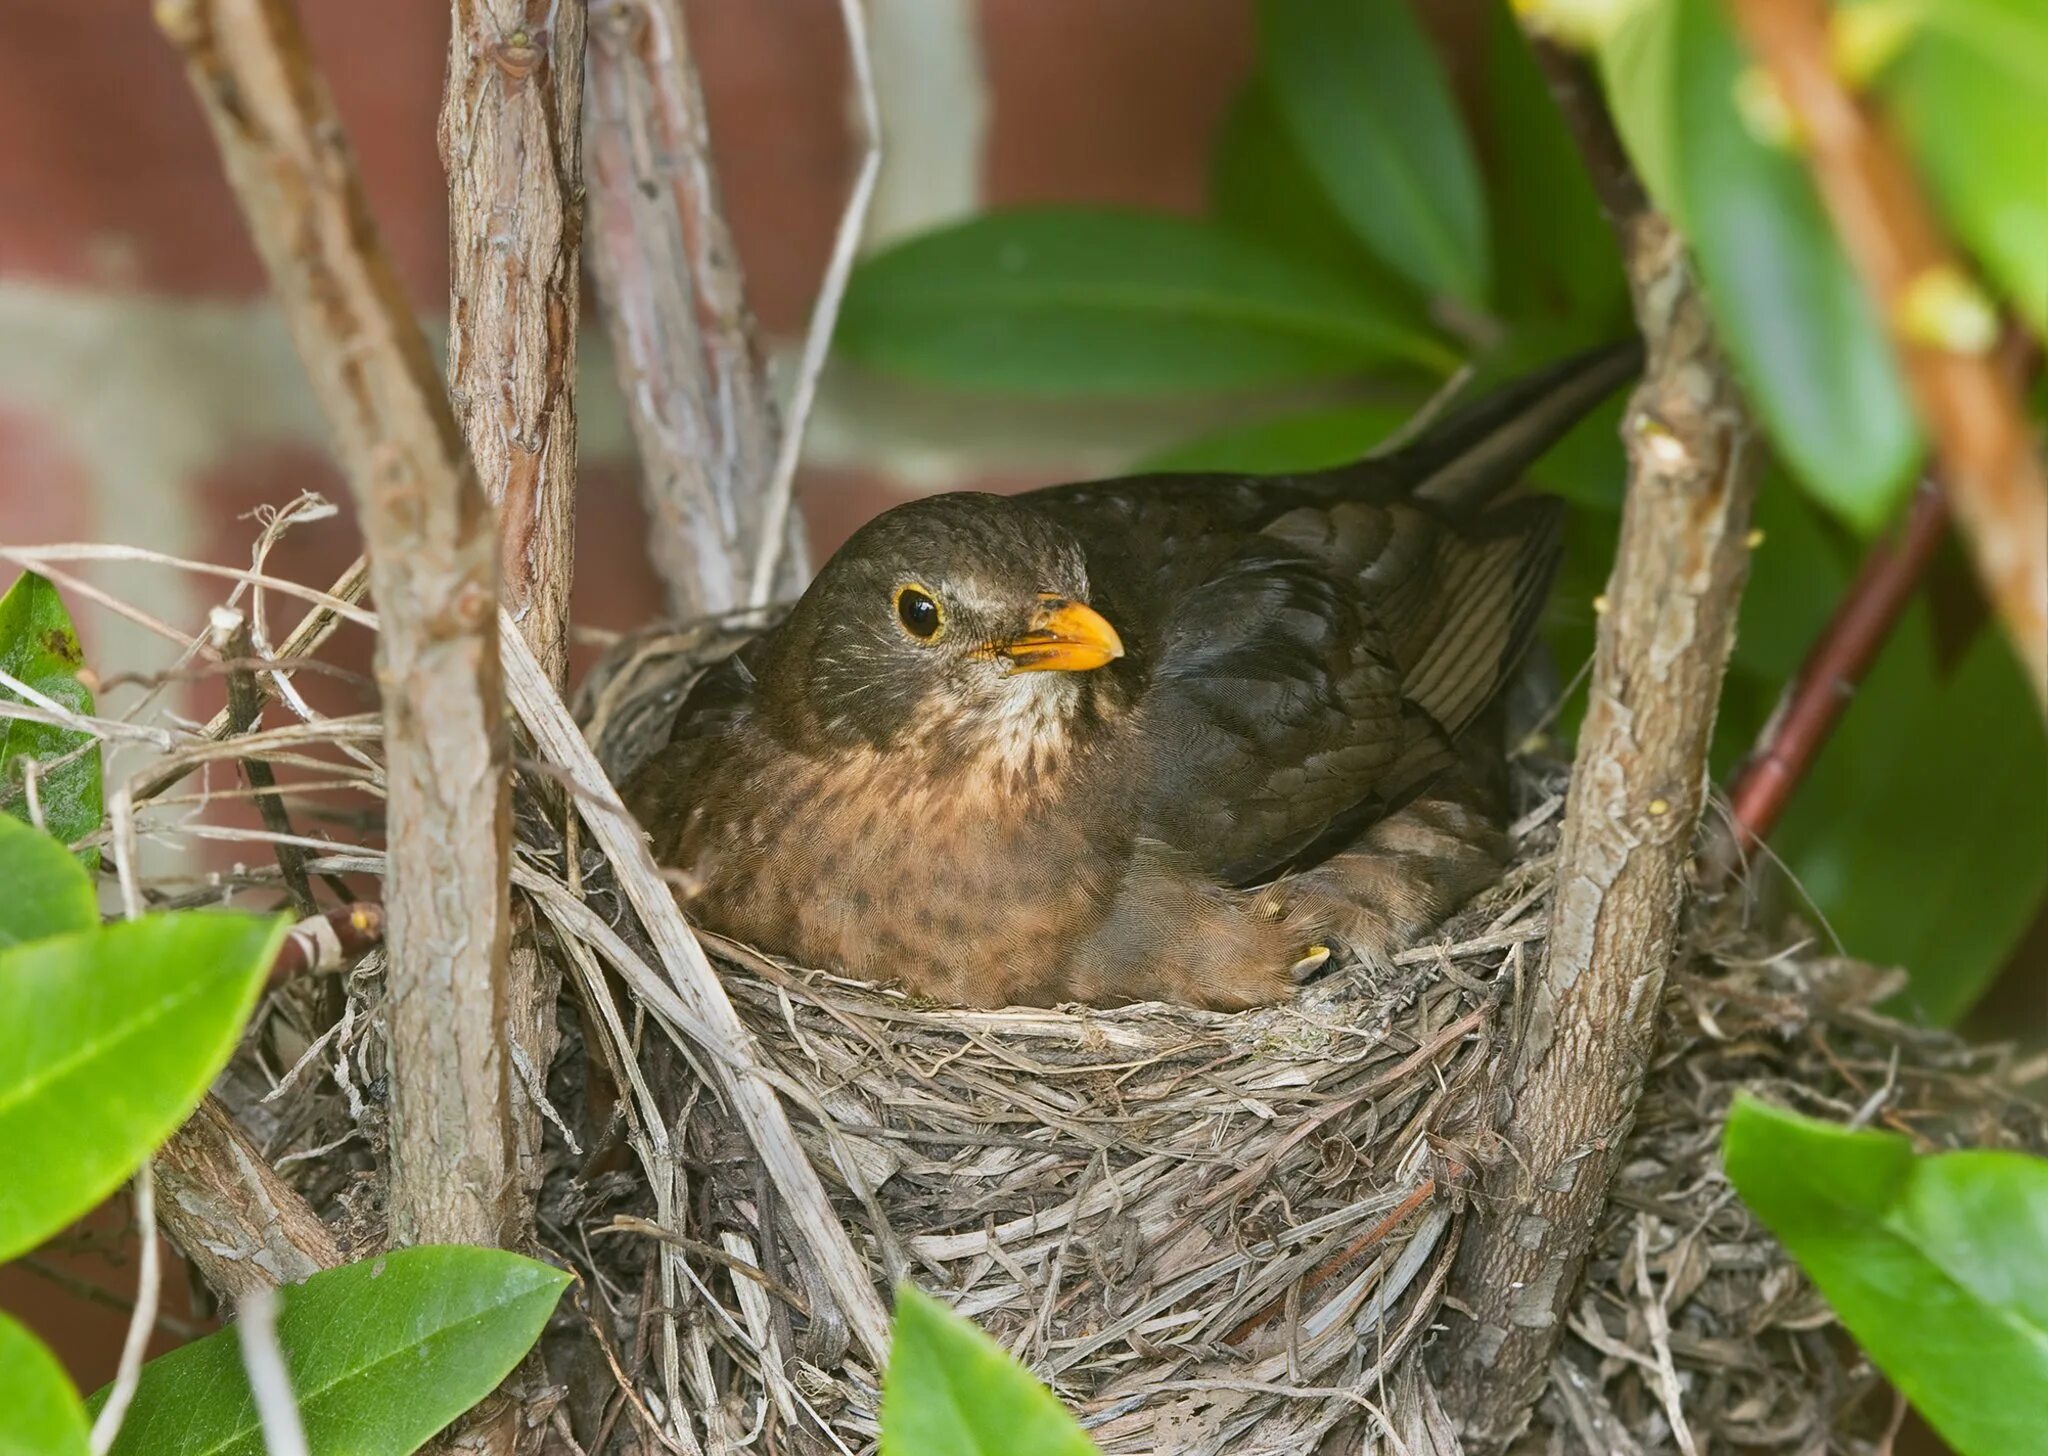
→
(154, 1098, 342, 1302)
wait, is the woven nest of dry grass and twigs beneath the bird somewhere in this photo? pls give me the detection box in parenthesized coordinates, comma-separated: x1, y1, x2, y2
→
(28, 524, 2048, 1456)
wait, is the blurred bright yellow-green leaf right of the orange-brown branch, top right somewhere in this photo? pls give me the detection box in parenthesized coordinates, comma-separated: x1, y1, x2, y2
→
(1866, 0, 2048, 334)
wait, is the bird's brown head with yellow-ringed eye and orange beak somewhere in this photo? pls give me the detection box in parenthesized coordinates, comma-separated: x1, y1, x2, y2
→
(764, 494, 1124, 752)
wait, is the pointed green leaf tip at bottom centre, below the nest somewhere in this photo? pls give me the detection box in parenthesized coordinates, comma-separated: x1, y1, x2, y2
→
(881, 1284, 1096, 1456)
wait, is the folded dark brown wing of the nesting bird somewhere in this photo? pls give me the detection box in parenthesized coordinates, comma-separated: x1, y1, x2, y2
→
(1141, 500, 1561, 885)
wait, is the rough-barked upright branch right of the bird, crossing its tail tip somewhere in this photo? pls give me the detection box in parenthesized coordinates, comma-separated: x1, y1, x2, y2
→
(1436, 59, 1755, 1448)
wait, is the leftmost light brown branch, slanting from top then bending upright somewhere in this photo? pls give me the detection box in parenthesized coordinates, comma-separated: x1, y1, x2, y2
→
(156, 0, 520, 1243)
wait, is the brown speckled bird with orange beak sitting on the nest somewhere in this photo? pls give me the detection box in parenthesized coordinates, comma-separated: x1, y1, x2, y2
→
(625, 344, 1638, 1010)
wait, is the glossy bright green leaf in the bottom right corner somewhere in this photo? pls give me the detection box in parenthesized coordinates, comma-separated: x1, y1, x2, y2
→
(1724, 1098, 2048, 1456)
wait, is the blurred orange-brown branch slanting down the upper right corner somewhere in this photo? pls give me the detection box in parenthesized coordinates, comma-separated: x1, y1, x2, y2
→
(1729, 0, 2048, 706)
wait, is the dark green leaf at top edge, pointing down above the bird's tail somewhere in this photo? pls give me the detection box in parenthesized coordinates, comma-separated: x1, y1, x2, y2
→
(1260, 0, 1489, 309)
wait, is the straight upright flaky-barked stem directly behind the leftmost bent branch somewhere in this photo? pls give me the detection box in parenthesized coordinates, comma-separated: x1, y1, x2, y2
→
(440, 0, 584, 1225)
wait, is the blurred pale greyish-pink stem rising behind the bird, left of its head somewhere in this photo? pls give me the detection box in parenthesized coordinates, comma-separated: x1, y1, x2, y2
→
(586, 0, 807, 618)
